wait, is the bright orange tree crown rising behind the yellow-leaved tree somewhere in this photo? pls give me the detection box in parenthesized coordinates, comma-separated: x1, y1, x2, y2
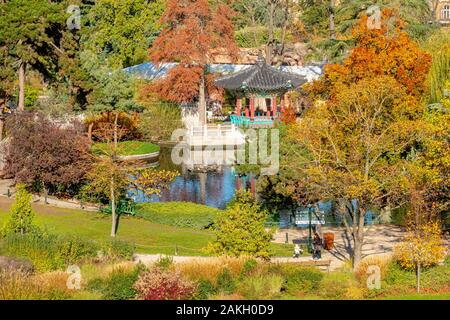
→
(309, 10, 431, 98)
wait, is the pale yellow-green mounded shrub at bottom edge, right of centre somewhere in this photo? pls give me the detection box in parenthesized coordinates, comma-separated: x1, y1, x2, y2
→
(238, 275, 284, 300)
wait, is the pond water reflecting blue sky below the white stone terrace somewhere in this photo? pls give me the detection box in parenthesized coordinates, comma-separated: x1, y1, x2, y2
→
(129, 148, 255, 209)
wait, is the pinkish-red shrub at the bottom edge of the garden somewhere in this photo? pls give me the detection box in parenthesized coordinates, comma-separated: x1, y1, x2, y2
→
(134, 268, 197, 300)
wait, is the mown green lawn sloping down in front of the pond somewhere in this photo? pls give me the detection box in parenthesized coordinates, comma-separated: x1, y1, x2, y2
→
(0, 197, 293, 256)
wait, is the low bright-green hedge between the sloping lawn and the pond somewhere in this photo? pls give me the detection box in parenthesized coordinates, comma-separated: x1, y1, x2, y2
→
(136, 202, 221, 230)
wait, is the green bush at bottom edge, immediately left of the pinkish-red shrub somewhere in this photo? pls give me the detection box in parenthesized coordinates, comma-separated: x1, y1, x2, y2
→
(88, 265, 145, 300)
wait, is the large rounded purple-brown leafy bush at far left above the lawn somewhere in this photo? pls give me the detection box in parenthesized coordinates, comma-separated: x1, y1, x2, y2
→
(5, 112, 91, 198)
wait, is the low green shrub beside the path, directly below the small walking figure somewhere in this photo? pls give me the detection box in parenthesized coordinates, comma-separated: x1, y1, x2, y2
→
(269, 264, 323, 293)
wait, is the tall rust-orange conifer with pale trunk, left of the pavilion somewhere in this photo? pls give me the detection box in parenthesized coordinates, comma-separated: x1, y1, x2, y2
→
(149, 0, 237, 124)
